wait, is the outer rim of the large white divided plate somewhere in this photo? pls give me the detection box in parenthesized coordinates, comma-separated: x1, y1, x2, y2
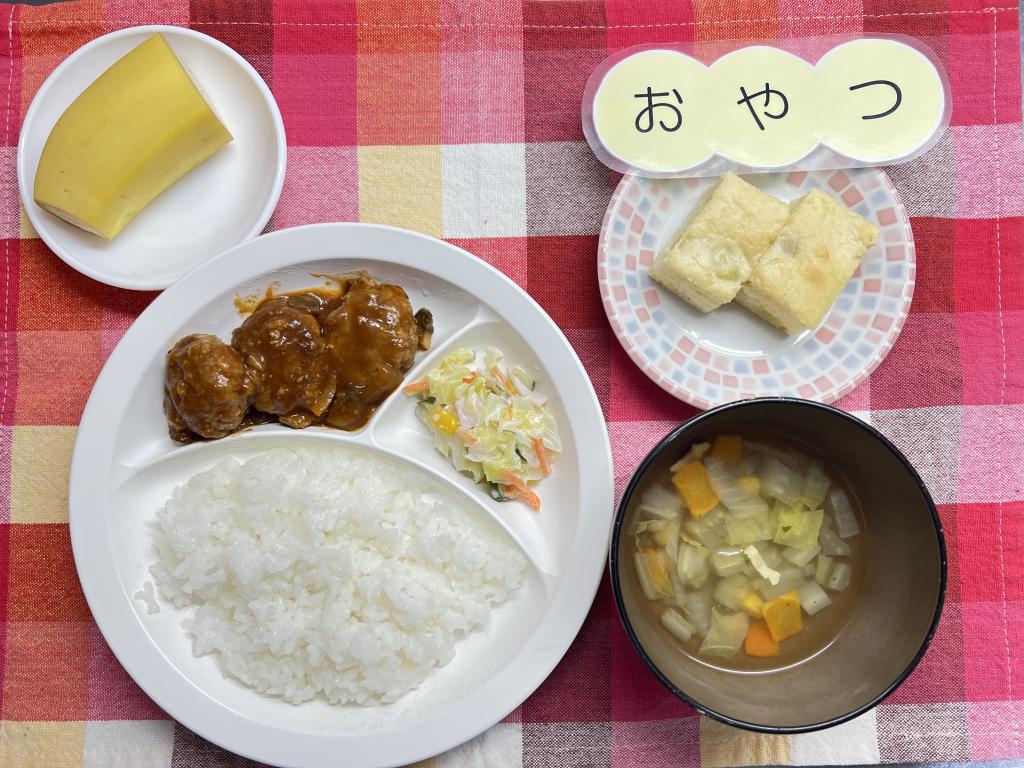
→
(69, 223, 614, 768)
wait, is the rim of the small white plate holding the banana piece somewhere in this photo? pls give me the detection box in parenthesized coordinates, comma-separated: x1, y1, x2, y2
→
(17, 25, 288, 291)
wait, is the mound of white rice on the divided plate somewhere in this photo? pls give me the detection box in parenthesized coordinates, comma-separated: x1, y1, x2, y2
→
(151, 447, 526, 706)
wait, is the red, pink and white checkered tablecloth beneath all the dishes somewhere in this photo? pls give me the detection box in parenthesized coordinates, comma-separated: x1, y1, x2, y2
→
(0, 0, 1024, 768)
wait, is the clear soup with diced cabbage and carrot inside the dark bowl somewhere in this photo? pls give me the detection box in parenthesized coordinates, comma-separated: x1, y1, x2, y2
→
(631, 434, 868, 672)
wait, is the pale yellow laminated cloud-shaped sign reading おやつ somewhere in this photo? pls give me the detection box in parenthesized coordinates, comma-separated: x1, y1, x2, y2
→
(584, 38, 949, 176)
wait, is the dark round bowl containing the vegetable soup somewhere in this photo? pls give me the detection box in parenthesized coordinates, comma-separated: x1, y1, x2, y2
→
(609, 397, 946, 733)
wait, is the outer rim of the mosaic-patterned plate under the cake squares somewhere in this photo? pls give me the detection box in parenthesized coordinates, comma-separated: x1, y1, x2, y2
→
(597, 167, 916, 411)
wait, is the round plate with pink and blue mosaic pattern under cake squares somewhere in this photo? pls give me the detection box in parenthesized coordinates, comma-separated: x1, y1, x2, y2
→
(597, 168, 915, 409)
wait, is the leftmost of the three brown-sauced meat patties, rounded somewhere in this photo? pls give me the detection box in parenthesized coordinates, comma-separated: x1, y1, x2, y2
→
(164, 334, 253, 442)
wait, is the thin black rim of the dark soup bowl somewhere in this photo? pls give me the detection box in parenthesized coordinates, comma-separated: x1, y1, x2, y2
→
(608, 396, 947, 734)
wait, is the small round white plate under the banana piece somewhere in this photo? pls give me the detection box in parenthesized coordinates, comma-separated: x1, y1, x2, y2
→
(17, 26, 288, 290)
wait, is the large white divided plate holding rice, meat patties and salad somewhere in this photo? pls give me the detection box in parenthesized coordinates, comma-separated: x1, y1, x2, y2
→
(70, 224, 613, 768)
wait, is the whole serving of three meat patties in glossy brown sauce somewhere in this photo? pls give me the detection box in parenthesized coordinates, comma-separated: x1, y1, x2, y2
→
(164, 270, 433, 442)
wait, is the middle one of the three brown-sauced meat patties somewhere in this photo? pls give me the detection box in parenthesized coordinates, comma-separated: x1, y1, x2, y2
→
(231, 298, 335, 428)
